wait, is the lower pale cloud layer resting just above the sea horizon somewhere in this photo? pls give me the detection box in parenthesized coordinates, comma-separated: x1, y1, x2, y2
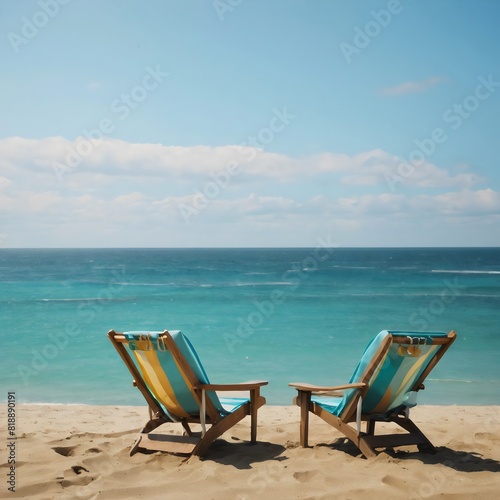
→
(4, 189, 500, 246)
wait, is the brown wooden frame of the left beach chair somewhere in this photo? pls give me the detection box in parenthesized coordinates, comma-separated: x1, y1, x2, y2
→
(108, 330, 268, 456)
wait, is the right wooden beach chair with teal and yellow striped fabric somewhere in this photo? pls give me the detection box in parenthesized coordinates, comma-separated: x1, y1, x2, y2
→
(289, 330, 456, 458)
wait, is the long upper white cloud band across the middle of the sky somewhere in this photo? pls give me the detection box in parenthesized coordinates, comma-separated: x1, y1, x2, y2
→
(0, 137, 481, 191)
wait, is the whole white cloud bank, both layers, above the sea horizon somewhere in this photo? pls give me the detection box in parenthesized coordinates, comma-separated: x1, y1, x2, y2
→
(0, 137, 500, 246)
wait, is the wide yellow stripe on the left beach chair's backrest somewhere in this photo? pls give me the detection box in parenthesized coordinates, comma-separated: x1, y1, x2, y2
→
(132, 350, 189, 417)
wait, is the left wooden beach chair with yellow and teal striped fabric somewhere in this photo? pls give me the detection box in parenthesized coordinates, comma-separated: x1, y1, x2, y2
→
(108, 330, 267, 455)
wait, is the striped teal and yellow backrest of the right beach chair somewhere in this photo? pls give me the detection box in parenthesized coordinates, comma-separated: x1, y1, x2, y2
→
(339, 330, 456, 417)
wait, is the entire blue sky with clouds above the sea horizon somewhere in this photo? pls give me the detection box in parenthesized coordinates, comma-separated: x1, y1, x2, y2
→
(0, 0, 500, 248)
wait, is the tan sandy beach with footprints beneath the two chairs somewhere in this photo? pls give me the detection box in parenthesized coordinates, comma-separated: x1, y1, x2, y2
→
(0, 404, 500, 500)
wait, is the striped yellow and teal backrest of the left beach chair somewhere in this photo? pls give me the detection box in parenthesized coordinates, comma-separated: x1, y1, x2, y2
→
(112, 330, 224, 420)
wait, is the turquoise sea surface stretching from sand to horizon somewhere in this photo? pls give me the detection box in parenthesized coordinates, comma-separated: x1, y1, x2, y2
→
(0, 246, 500, 405)
